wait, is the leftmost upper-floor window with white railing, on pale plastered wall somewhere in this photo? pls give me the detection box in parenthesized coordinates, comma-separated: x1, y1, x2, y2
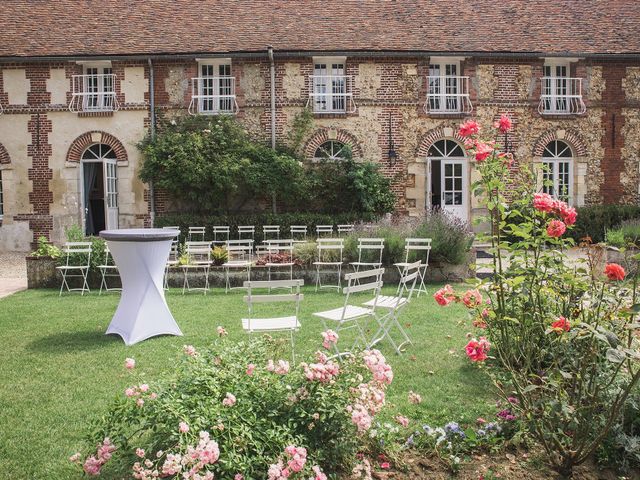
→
(69, 62, 119, 112)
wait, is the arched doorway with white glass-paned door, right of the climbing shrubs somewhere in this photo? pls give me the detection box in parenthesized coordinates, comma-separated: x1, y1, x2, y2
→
(427, 139, 469, 221)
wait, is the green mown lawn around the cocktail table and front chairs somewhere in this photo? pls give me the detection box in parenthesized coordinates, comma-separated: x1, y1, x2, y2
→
(0, 286, 494, 479)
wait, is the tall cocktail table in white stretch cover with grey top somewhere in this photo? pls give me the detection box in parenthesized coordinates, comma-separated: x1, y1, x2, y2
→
(100, 228, 182, 345)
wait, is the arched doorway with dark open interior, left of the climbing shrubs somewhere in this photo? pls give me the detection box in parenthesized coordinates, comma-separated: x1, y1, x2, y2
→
(81, 143, 118, 235)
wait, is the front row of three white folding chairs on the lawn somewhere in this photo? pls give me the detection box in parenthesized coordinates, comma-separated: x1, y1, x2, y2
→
(242, 260, 421, 362)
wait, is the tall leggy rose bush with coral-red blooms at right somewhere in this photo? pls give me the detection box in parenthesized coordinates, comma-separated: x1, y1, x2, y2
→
(434, 118, 640, 476)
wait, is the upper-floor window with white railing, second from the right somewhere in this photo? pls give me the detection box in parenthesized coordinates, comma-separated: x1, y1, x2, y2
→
(424, 57, 473, 114)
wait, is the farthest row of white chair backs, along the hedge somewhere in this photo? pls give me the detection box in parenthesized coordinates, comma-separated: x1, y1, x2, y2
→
(162, 224, 355, 245)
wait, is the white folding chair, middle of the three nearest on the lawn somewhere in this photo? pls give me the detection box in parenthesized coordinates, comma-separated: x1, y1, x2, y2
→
(313, 268, 384, 357)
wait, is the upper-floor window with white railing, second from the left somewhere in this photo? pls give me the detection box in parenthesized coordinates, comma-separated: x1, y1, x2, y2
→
(189, 59, 238, 115)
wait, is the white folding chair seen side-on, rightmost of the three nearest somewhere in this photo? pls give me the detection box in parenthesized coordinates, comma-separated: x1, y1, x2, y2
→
(363, 260, 422, 355)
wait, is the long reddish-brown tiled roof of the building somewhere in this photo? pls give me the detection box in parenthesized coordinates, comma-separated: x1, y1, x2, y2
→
(0, 0, 640, 57)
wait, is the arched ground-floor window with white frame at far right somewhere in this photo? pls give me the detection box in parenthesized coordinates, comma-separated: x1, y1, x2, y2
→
(542, 140, 573, 202)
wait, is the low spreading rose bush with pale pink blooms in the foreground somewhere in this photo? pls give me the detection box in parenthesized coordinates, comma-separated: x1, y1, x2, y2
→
(70, 331, 393, 480)
